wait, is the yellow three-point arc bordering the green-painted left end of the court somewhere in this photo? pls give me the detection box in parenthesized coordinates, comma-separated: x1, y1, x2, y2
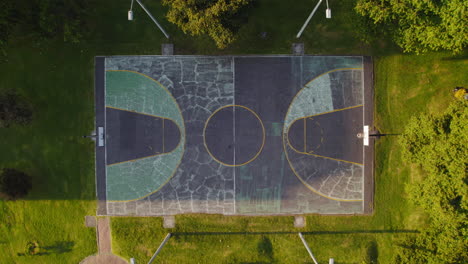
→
(106, 70, 186, 202)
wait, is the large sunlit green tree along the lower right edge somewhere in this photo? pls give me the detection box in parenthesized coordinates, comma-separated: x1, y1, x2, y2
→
(395, 101, 468, 263)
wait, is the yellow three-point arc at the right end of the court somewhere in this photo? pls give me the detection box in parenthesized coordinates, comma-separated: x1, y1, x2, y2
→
(283, 68, 363, 202)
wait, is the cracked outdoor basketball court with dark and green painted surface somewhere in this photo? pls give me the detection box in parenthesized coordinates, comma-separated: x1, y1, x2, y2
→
(95, 55, 373, 216)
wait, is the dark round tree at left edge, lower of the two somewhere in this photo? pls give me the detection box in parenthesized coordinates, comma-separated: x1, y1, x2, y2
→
(0, 168, 32, 200)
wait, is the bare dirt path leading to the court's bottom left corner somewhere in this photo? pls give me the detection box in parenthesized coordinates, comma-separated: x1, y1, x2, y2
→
(80, 217, 128, 264)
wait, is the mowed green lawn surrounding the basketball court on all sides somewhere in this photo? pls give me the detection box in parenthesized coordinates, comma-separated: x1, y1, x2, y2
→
(0, 0, 468, 263)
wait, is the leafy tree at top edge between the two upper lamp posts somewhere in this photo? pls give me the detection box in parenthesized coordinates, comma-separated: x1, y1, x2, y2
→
(163, 0, 251, 49)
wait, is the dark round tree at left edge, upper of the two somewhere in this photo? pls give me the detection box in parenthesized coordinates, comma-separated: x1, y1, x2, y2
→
(0, 92, 32, 128)
